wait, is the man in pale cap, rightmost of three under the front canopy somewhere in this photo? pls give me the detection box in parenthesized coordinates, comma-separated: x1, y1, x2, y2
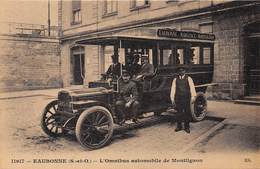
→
(135, 55, 154, 80)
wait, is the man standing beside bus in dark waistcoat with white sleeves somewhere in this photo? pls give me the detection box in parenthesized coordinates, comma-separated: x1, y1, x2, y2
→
(170, 66, 196, 133)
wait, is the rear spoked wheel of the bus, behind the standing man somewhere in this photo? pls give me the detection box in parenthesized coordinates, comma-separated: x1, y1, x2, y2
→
(191, 92, 207, 121)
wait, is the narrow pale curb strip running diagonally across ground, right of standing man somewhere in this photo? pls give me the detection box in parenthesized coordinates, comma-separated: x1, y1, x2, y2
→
(179, 120, 226, 153)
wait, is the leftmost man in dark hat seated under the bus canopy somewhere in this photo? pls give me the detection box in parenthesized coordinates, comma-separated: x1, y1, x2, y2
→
(105, 55, 122, 79)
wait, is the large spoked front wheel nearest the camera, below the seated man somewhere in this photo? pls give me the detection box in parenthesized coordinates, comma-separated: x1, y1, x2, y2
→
(76, 106, 113, 149)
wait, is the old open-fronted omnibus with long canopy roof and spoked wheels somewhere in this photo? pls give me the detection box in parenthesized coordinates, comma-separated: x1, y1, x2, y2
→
(41, 28, 215, 149)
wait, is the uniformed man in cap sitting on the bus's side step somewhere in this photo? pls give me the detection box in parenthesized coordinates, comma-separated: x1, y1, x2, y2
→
(116, 70, 139, 124)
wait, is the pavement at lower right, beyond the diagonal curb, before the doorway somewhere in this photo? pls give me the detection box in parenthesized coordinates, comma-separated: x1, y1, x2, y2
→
(188, 101, 260, 153)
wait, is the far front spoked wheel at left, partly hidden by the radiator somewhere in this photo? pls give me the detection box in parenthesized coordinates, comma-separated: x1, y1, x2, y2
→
(41, 100, 63, 137)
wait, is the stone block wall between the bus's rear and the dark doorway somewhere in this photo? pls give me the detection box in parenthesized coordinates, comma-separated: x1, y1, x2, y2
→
(209, 7, 260, 99)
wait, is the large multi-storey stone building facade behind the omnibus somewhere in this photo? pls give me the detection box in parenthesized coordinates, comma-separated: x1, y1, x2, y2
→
(59, 0, 260, 99)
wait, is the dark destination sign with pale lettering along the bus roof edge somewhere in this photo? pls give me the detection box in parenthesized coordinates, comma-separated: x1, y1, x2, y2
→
(157, 29, 215, 40)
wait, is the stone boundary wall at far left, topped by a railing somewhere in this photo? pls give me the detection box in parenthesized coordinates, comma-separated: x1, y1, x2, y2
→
(0, 35, 62, 91)
